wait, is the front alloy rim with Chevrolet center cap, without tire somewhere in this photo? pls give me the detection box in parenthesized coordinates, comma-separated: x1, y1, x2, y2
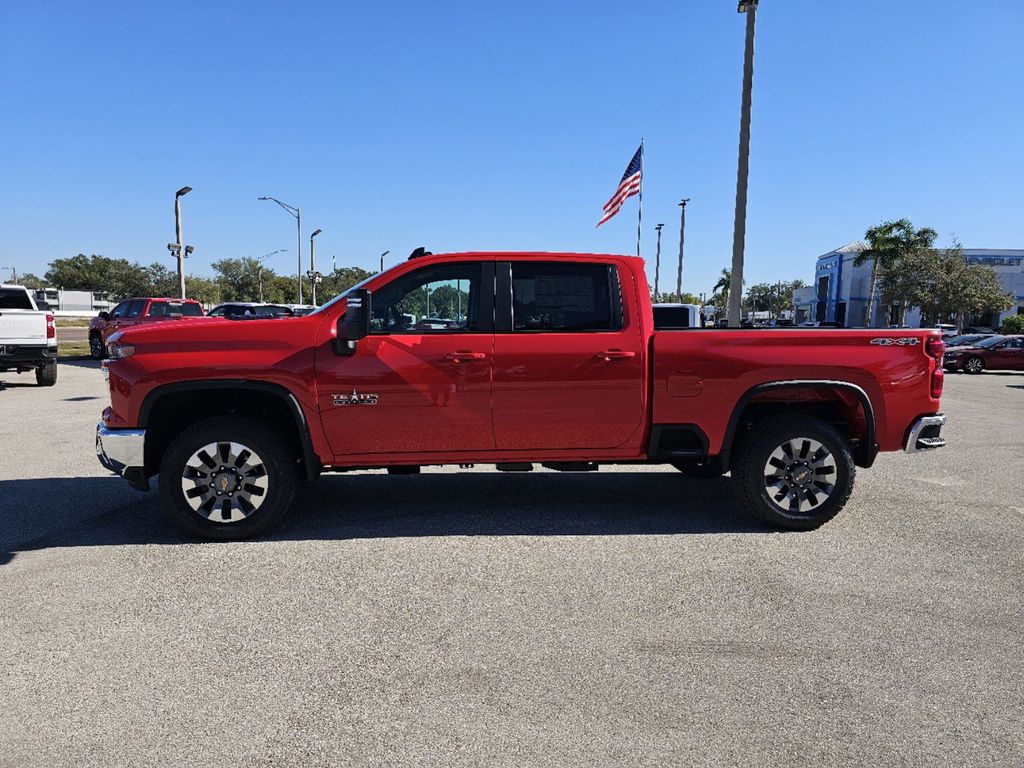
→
(181, 442, 267, 522)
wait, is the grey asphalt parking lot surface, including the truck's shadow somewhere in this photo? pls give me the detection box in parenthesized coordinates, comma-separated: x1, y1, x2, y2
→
(0, 361, 1024, 766)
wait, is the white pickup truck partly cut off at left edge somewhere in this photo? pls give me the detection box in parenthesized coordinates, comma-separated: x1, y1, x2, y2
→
(0, 285, 57, 387)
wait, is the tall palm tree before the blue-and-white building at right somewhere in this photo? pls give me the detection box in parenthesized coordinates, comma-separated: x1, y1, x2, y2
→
(853, 219, 938, 327)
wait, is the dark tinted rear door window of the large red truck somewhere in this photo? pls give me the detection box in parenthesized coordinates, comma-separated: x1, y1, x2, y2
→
(512, 261, 623, 333)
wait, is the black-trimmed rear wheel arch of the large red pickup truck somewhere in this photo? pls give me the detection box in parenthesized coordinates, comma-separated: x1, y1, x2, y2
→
(721, 379, 879, 467)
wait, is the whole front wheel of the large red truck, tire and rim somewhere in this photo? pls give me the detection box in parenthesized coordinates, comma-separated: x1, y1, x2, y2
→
(160, 416, 298, 541)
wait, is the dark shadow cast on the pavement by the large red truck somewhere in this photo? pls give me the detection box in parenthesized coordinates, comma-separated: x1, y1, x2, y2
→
(0, 472, 771, 565)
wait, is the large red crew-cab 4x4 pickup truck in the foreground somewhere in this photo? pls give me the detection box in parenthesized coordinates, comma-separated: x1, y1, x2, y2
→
(96, 253, 945, 539)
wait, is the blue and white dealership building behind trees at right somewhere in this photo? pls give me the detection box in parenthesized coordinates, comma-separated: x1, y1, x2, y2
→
(793, 240, 1024, 329)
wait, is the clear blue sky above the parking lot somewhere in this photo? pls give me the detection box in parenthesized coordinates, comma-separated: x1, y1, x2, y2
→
(0, 0, 1024, 292)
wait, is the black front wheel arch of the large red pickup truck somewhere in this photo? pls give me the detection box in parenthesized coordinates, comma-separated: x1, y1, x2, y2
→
(138, 379, 322, 479)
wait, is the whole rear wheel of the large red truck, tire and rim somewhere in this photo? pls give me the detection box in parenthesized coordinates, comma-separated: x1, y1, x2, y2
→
(732, 417, 856, 530)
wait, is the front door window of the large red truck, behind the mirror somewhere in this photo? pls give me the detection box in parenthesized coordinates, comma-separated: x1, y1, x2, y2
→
(370, 262, 481, 334)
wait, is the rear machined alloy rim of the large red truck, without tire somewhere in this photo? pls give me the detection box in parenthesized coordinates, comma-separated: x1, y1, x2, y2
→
(765, 437, 836, 515)
